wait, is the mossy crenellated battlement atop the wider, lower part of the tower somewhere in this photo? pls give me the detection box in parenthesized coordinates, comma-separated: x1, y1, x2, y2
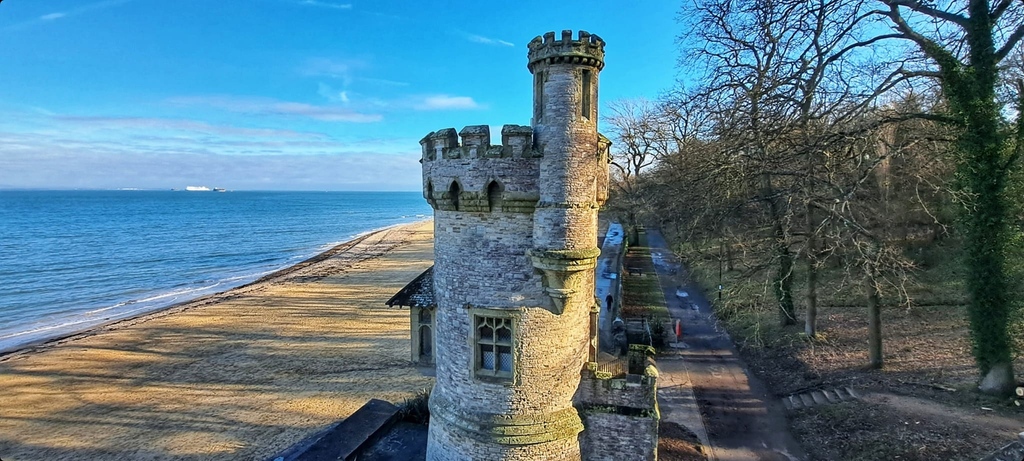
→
(420, 125, 541, 163)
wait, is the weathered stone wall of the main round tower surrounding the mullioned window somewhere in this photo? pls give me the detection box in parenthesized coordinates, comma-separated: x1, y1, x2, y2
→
(430, 210, 593, 459)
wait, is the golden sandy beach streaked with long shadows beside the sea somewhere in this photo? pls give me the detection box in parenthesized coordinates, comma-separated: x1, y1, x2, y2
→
(0, 221, 433, 461)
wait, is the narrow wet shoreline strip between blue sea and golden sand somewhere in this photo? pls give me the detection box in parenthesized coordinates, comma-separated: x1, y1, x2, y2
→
(0, 218, 433, 363)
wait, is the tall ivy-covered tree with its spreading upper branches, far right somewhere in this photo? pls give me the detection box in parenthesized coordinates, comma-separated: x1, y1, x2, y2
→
(880, 0, 1024, 393)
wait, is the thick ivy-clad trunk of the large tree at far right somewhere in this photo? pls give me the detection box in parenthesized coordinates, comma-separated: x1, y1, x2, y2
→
(939, 1, 1014, 394)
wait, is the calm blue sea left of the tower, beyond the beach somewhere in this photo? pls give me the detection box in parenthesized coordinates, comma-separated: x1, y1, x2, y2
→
(0, 191, 431, 350)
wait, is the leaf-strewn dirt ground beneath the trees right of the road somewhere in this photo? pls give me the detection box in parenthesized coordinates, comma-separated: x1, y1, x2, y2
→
(742, 306, 1024, 461)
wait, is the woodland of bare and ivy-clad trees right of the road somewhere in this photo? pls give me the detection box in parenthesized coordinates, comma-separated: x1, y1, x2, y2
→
(603, 0, 1024, 454)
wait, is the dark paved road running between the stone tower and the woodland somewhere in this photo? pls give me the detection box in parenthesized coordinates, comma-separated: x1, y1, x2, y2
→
(647, 229, 807, 461)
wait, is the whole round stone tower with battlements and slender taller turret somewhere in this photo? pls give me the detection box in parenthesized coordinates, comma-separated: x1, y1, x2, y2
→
(420, 31, 608, 461)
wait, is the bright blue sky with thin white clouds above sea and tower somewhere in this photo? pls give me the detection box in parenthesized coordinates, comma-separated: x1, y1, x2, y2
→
(0, 0, 680, 191)
